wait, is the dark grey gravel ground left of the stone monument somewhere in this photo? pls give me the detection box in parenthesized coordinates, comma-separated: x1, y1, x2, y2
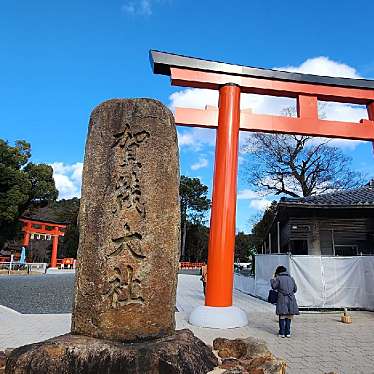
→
(0, 274, 74, 314)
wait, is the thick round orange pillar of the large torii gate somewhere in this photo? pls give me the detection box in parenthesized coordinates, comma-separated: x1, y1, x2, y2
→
(205, 84, 240, 307)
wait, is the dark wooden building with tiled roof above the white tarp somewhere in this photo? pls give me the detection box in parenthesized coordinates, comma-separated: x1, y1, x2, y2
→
(263, 180, 374, 256)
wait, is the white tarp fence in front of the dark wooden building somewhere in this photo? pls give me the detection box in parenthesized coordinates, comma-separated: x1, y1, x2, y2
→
(235, 255, 374, 310)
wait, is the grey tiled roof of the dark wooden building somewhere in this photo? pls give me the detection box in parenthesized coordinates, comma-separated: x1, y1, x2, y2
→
(280, 180, 374, 207)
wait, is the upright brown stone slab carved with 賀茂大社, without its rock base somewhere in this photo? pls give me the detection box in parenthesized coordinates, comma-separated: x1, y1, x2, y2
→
(72, 99, 180, 341)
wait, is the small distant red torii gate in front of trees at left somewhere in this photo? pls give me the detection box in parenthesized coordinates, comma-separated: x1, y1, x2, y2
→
(19, 218, 66, 268)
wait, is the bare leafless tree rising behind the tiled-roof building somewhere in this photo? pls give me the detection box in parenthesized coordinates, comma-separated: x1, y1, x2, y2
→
(242, 108, 363, 197)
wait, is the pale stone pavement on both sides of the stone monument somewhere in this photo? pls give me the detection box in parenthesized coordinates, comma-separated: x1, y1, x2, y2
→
(0, 275, 374, 374)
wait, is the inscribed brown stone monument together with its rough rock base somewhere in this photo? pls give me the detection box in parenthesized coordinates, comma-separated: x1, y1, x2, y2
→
(6, 99, 217, 374)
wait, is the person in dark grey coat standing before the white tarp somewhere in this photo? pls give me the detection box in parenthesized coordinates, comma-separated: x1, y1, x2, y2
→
(270, 265, 300, 338)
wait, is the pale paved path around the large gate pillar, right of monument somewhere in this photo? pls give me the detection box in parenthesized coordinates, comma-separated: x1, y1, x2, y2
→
(177, 276, 374, 374)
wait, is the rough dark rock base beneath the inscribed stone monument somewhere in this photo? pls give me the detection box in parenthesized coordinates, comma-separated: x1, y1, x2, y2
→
(5, 330, 218, 374)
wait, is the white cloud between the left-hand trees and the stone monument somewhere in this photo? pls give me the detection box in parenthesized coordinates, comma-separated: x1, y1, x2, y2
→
(51, 162, 83, 199)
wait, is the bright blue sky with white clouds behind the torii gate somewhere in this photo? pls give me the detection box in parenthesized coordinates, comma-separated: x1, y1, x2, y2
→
(0, 0, 374, 231)
